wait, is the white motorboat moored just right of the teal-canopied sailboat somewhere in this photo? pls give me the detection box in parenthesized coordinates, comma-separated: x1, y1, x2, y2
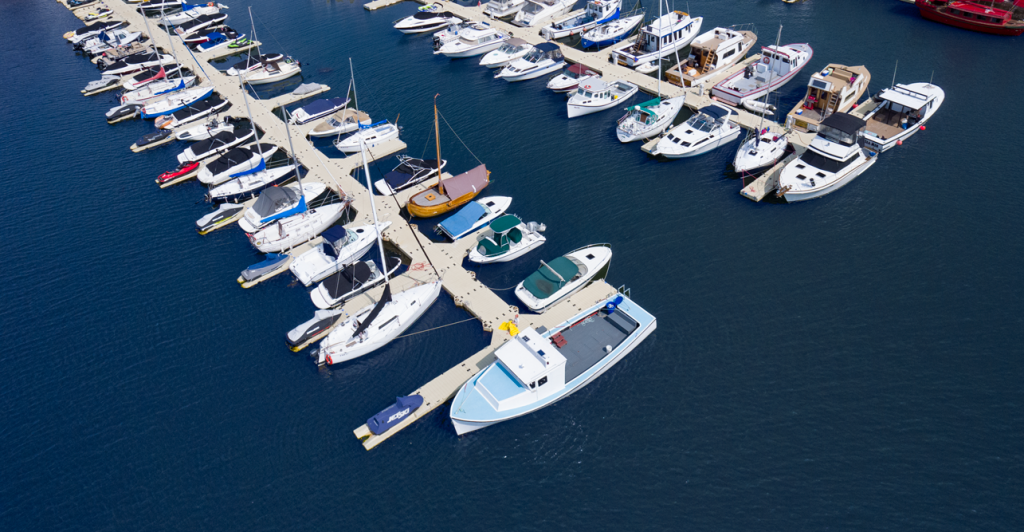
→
(650, 103, 743, 159)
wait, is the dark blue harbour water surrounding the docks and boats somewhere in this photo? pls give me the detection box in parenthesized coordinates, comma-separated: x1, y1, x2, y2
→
(0, 0, 1024, 531)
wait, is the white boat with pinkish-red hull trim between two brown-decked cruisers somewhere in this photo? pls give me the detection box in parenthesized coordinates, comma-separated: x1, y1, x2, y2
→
(711, 43, 814, 105)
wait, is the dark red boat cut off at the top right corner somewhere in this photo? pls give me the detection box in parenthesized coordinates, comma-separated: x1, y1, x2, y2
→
(916, 0, 1024, 35)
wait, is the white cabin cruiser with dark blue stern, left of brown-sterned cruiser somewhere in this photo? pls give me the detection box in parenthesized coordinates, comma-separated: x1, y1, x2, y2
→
(611, 11, 703, 69)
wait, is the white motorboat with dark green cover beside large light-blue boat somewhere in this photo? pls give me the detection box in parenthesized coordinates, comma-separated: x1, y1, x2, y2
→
(515, 243, 611, 314)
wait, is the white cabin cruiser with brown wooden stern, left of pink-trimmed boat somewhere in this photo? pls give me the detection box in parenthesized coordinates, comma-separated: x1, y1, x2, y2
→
(665, 28, 758, 87)
